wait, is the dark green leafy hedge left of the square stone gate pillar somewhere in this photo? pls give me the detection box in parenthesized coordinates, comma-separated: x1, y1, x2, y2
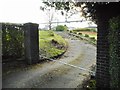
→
(2, 23, 24, 58)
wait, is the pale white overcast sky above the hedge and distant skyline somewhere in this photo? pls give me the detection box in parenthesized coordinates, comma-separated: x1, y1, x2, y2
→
(0, 0, 96, 27)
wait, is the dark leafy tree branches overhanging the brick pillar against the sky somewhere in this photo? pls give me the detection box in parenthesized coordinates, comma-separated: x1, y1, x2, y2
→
(44, 2, 120, 23)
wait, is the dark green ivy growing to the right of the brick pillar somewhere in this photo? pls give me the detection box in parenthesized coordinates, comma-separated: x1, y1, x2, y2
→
(108, 16, 120, 88)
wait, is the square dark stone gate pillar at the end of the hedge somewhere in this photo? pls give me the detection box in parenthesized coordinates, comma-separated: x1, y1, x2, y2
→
(24, 23, 39, 64)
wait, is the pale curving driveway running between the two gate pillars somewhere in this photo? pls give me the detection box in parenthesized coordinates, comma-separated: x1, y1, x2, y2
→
(2, 32, 96, 88)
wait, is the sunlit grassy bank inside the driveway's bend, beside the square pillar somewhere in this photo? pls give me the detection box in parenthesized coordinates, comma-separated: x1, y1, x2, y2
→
(39, 31, 67, 58)
